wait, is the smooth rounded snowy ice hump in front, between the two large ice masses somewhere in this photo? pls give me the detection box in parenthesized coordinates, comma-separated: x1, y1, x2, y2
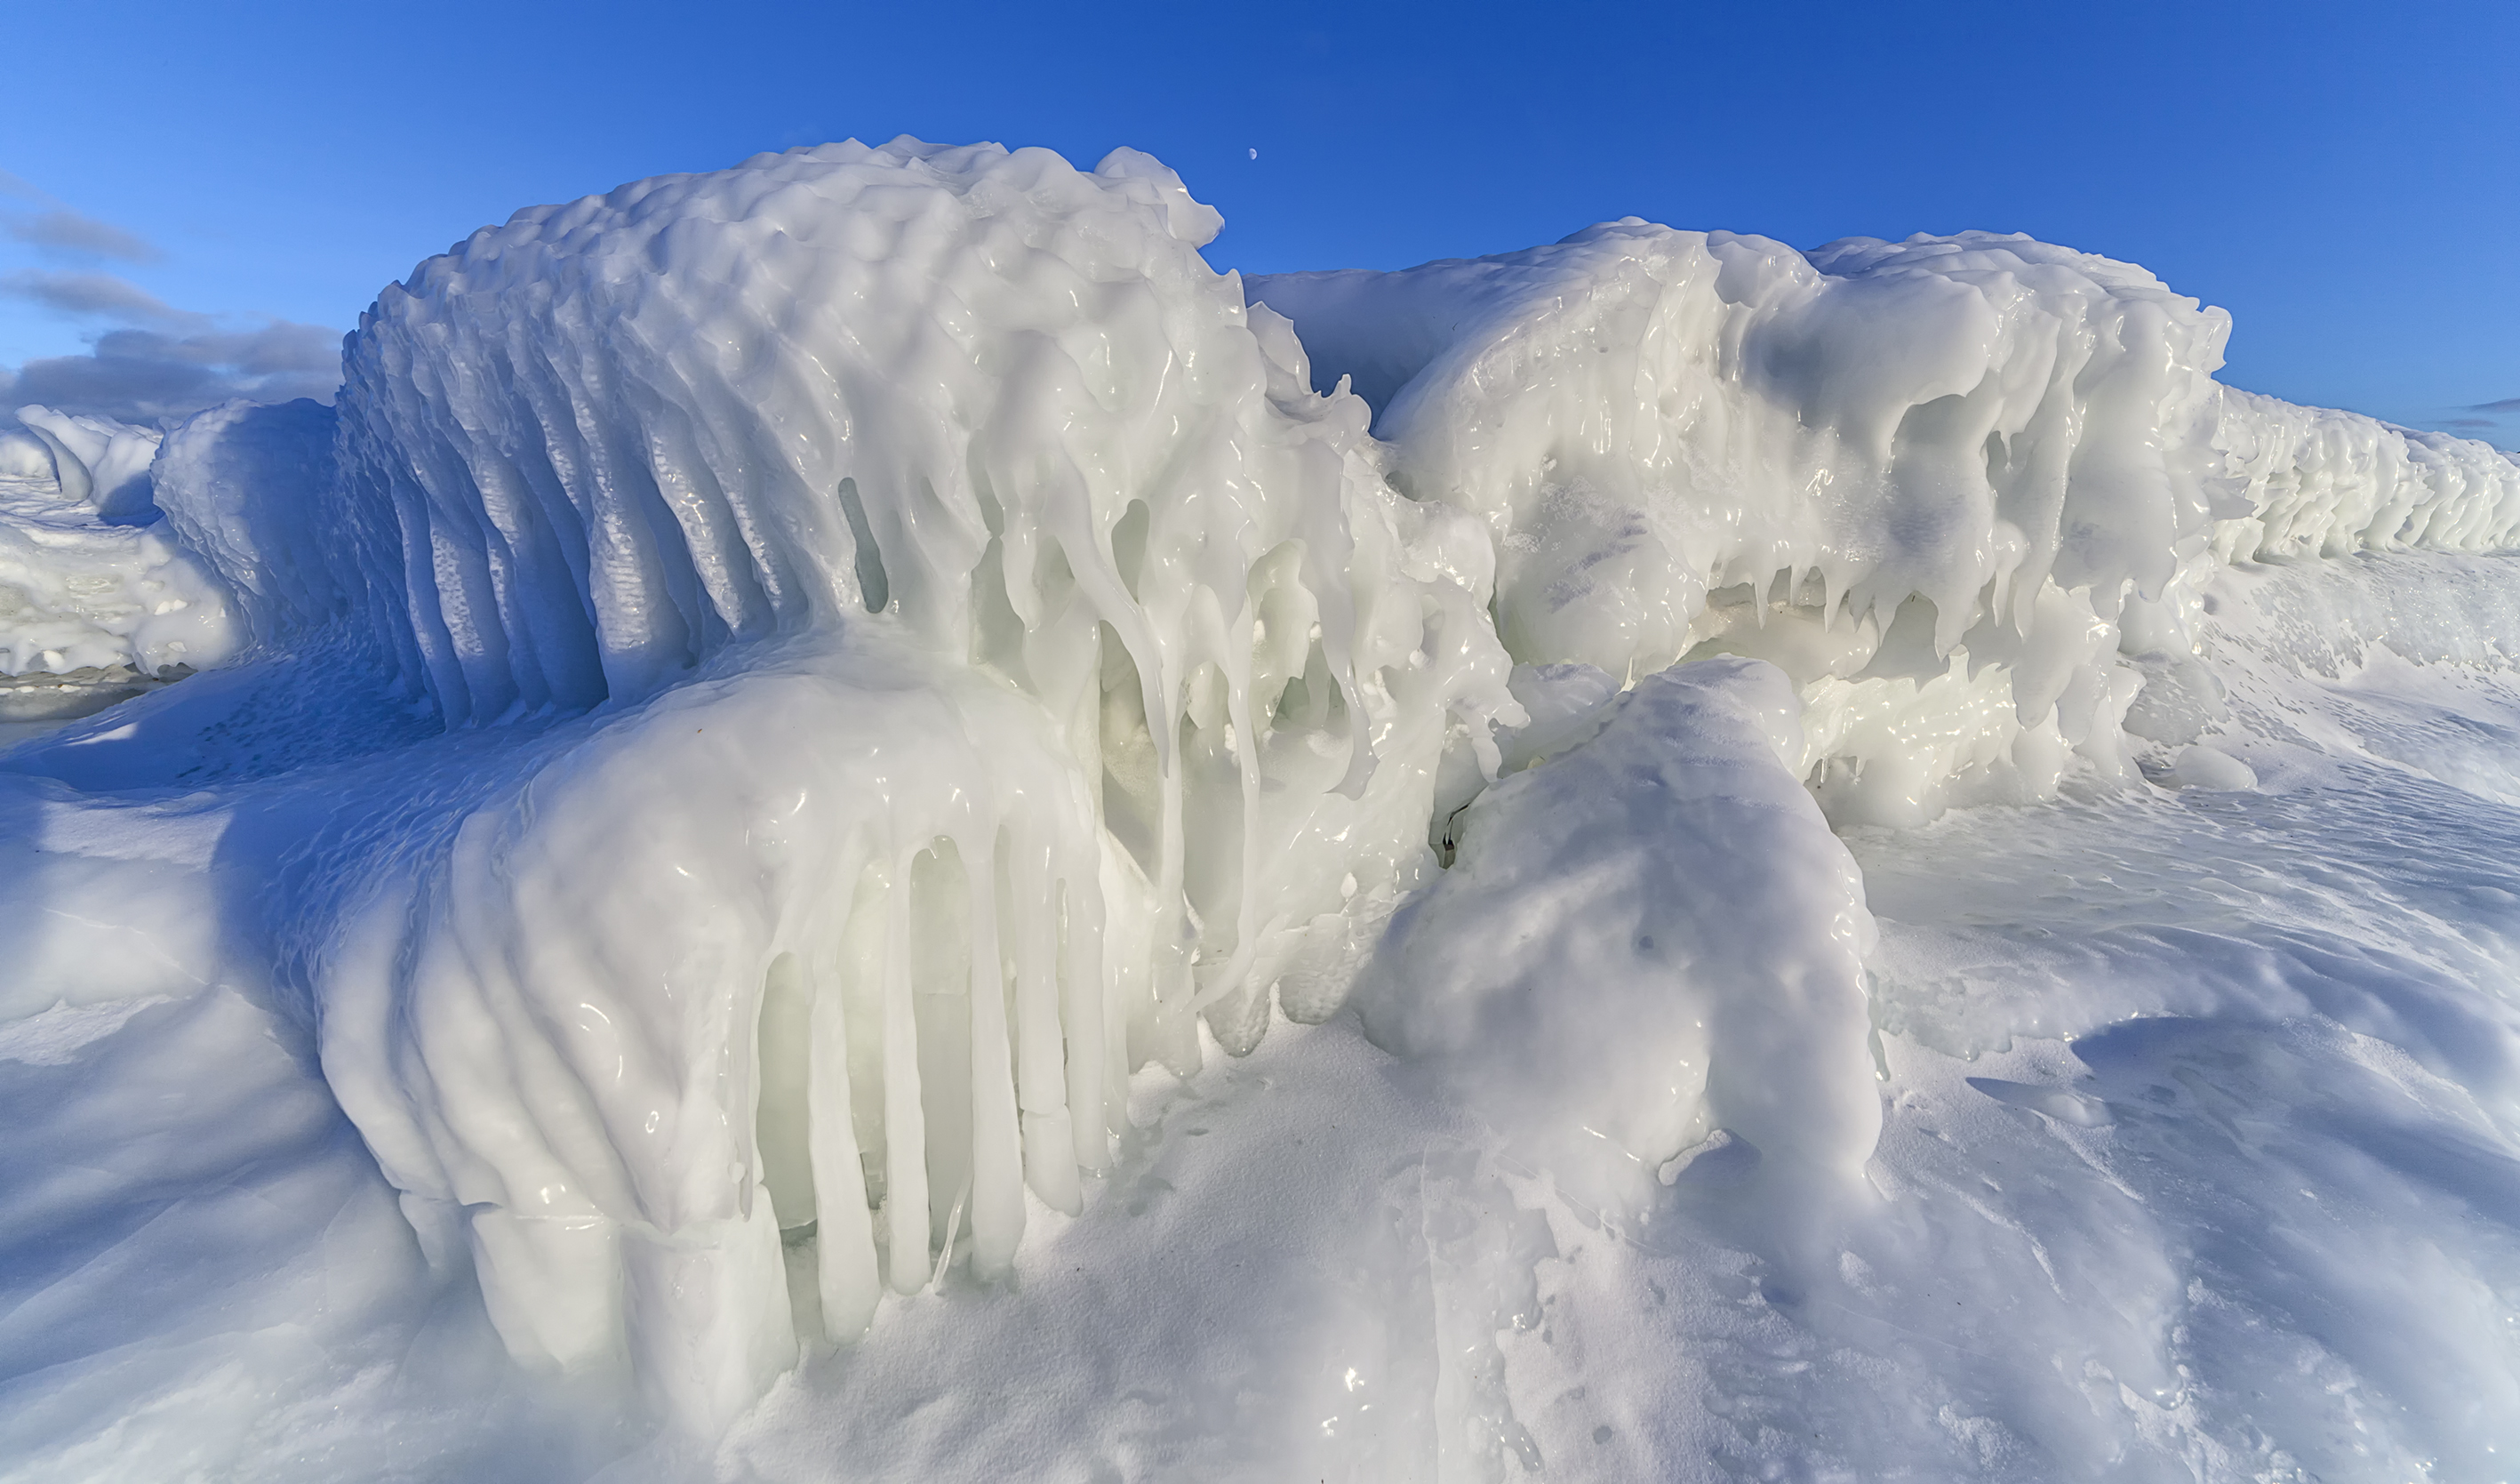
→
(1364, 660, 1880, 1212)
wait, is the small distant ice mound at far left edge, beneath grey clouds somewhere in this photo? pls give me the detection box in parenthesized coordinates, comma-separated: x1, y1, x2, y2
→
(0, 405, 242, 685)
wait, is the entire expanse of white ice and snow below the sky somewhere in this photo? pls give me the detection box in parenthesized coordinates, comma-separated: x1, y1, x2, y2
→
(0, 141, 2520, 1481)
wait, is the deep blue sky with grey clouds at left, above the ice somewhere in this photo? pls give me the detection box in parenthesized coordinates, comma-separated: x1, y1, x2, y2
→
(0, 0, 2520, 446)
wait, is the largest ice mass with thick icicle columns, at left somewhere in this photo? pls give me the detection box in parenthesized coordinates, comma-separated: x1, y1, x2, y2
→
(297, 141, 1517, 1426)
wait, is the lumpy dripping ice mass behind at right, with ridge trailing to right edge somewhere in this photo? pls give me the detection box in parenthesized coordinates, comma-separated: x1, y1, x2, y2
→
(1247, 220, 2520, 824)
